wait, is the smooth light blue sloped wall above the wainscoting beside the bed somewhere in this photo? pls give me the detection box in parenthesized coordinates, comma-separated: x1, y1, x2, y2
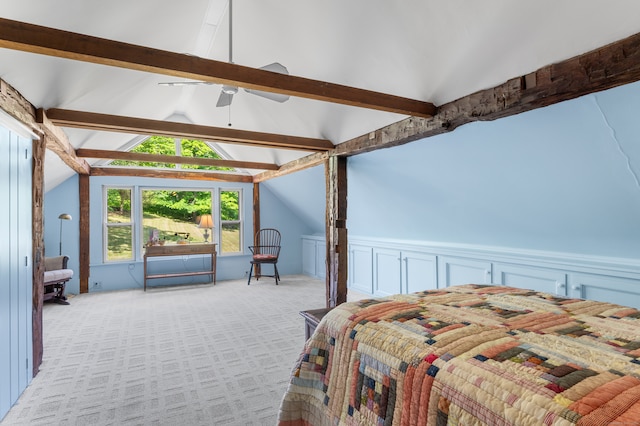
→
(347, 83, 640, 258)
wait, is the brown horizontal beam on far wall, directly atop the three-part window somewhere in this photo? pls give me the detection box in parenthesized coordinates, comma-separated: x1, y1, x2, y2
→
(91, 167, 253, 183)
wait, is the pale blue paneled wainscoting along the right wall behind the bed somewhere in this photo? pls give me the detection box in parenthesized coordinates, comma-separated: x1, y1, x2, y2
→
(302, 236, 640, 308)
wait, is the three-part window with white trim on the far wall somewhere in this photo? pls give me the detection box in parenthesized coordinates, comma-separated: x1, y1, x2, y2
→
(103, 186, 243, 262)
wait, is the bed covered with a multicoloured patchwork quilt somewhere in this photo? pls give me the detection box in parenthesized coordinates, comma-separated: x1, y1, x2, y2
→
(278, 284, 640, 426)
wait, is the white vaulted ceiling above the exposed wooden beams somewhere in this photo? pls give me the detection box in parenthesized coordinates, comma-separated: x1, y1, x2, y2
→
(0, 0, 640, 189)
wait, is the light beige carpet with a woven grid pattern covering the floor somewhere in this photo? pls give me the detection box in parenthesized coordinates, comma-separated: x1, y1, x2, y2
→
(0, 276, 325, 426)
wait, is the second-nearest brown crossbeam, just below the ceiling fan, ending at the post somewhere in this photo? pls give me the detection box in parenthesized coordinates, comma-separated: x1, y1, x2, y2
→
(47, 108, 333, 151)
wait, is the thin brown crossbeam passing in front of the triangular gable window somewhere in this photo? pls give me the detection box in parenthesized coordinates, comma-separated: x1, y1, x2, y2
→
(76, 148, 279, 170)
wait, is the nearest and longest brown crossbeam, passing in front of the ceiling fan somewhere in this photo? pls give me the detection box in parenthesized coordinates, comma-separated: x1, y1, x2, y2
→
(0, 18, 436, 117)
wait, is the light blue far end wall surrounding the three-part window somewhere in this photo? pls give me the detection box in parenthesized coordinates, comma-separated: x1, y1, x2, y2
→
(44, 176, 310, 293)
